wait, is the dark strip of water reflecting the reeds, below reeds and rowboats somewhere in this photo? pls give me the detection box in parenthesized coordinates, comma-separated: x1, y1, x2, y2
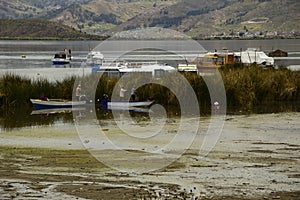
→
(0, 102, 300, 131)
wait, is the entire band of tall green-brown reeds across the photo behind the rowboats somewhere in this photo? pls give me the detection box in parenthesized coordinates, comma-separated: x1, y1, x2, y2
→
(0, 64, 300, 111)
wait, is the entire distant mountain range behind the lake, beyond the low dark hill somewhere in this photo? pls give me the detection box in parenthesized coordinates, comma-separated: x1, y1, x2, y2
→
(0, 0, 300, 37)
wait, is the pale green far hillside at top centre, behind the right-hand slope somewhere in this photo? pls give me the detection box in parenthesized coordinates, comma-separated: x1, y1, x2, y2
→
(54, 0, 178, 34)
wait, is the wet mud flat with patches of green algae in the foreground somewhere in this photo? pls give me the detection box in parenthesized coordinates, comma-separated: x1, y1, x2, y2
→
(0, 113, 300, 199)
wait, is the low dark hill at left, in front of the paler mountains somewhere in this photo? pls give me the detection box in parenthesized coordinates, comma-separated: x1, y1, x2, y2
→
(0, 19, 104, 40)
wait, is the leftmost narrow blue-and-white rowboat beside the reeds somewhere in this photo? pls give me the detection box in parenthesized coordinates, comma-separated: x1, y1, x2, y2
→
(30, 99, 86, 109)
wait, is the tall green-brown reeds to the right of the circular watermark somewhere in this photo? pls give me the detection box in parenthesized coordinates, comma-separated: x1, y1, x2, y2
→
(220, 65, 300, 110)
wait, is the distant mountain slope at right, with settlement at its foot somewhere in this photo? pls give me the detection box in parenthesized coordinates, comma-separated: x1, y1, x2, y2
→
(118, 0, 300, 36)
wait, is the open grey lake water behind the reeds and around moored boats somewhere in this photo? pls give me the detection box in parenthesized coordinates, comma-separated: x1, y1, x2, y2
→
(0, 39, 300, 74)
